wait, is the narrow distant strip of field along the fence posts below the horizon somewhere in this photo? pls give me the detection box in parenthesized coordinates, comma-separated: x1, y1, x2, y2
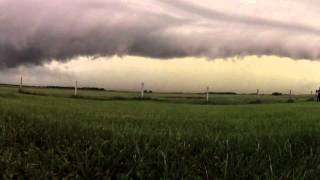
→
(0, 86, 315, 105)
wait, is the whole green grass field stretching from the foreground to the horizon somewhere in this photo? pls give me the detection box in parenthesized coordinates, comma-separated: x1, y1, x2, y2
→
(0, 86, 320, 179)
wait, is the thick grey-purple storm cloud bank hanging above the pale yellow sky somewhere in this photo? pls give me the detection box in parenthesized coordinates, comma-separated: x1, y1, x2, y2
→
(0, 0, 320, 67)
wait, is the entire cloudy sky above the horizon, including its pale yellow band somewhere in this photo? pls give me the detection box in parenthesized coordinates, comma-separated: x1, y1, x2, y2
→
(0, 0, 320, 93)
